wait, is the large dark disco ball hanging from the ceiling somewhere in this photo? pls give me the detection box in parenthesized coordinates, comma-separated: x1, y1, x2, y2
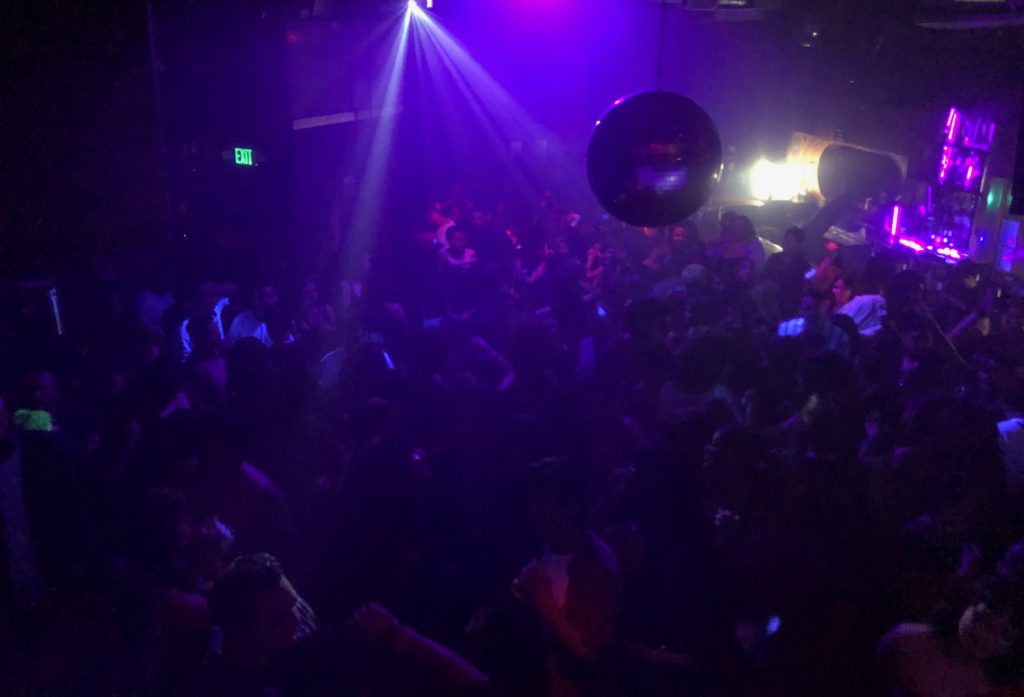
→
(587, 91, 722, 227)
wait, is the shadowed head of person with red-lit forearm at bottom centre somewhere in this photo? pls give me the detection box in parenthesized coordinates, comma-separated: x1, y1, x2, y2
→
(527, 458, 591, 552)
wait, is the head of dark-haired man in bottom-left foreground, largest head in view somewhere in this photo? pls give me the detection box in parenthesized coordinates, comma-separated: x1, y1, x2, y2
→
(209, 554, 299, 664)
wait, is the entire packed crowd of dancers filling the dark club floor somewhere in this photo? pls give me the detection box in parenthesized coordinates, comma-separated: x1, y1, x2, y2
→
(0, 187, 1024, 697)
